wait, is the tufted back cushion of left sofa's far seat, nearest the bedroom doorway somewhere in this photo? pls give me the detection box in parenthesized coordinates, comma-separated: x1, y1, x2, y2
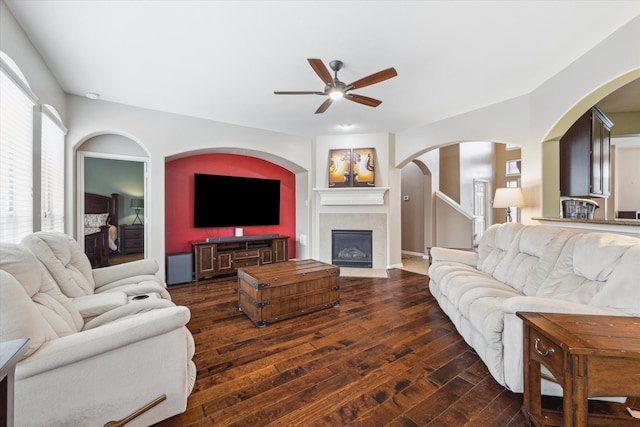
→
(22, 232, 95, 298)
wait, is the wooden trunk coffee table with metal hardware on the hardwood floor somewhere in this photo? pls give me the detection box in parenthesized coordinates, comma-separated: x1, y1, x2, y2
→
(238, 260, 340, 327)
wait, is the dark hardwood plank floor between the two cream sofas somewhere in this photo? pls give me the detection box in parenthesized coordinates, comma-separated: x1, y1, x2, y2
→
(152, 270, 529, 427)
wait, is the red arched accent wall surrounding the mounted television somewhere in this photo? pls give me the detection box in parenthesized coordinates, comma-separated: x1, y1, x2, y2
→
(165, 154, 296, 258)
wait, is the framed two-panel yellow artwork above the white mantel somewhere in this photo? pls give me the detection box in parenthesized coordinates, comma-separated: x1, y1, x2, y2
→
(329, 148, 376, 188)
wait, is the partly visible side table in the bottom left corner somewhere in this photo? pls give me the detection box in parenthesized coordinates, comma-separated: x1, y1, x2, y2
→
(0, 338, 29, 427)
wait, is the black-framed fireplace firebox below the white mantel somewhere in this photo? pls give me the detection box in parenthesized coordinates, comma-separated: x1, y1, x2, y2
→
(331, 230, 373, 268)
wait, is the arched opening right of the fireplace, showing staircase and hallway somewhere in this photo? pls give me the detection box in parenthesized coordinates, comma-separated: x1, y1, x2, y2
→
(401, 141, 521, 264)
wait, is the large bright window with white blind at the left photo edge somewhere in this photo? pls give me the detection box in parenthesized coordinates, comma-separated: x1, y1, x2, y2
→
(0, 68, 35, 243)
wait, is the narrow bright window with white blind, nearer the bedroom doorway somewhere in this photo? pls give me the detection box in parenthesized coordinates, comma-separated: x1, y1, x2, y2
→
(40, 106, 67, 232)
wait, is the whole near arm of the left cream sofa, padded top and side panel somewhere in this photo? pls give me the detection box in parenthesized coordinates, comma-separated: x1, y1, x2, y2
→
(14, 307, 196, 427)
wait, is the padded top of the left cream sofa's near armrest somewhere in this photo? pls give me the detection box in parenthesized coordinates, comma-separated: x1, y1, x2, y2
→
(16, 306, 191, 380)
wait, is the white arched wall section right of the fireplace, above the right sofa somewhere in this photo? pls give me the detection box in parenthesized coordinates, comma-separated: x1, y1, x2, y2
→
(395, 17, 640, 223)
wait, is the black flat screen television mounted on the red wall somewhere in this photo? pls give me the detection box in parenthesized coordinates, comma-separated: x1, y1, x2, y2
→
(193, 173, 280, 228)
